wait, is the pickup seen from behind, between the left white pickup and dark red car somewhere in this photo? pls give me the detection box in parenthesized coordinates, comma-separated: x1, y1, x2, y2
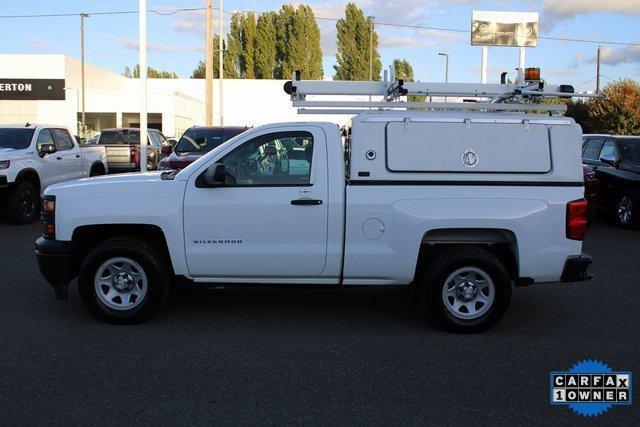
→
(98, 128, 171, 172)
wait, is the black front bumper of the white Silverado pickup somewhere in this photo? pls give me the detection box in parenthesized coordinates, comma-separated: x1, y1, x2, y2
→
(36, 237, 73, 301)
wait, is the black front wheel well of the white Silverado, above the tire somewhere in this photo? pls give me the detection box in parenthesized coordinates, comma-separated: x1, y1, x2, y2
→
(71, 224, 173, 272)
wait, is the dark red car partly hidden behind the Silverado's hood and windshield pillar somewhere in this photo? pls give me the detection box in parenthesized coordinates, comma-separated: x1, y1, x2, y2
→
(158, 126, 249, 170)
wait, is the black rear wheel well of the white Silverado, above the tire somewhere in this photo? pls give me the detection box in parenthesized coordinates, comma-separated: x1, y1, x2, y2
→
(415, 228, 519, 280)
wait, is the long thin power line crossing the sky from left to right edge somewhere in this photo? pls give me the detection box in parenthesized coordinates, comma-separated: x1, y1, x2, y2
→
(0, 7, 640, 47)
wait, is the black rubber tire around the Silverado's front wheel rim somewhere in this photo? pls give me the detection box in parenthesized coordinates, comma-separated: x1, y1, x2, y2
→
(78, 237, 172, 324)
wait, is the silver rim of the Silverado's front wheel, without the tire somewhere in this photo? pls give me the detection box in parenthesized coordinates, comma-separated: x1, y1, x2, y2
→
(93, 257, 149, 310)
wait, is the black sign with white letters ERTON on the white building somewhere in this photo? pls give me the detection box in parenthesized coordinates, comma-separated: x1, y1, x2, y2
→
(0, 79, 65, 101)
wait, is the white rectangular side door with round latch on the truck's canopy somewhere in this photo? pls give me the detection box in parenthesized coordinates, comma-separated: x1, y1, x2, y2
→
(386, 121, 551, 173)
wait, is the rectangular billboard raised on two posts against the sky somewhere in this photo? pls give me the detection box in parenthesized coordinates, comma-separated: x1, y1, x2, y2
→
(471, 11, 538, 47)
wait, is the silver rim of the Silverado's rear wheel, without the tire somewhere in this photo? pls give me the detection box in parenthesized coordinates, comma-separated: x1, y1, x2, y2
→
(442, 266, 496, 320)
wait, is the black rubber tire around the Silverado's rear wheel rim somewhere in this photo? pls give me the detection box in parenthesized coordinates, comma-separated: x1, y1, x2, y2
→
(418, 246, 511, 333)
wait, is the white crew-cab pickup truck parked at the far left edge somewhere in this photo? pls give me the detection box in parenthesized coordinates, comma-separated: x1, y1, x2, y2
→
(0, 124, 107, 224)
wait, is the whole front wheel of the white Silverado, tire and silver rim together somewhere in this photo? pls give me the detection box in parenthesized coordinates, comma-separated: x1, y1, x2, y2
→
(78, 237, 171, 324)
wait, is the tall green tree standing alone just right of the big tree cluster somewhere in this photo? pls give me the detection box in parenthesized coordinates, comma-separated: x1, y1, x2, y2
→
(333, 3, 382, 80)
